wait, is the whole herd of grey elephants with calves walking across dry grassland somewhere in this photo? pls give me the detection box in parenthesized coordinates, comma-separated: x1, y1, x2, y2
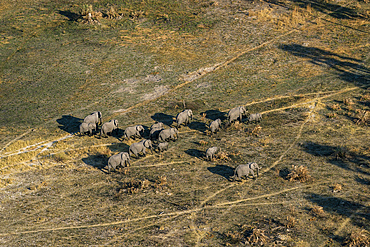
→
(79, 106, 262, 180)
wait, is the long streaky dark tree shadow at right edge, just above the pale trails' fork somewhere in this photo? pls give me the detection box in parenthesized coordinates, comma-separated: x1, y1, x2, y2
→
(279, 44, 370, 86)
